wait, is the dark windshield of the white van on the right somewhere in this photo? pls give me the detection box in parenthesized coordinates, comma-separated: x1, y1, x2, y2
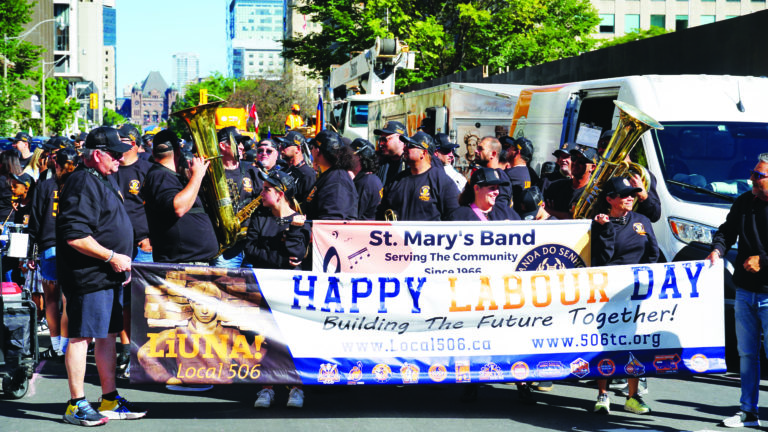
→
(652, 122, 768, 206)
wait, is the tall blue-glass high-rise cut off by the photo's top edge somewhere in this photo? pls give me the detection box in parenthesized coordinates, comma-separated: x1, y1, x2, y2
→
(227, 0, 285, 79)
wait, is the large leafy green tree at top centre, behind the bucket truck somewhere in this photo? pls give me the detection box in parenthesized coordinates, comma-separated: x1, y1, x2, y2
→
(283, 0, 600, 87)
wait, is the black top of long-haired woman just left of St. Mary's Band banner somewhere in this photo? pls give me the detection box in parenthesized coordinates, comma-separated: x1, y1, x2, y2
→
(245, 212, 311, 269)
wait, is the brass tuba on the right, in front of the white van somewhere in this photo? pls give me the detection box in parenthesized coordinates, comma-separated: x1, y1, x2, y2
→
(573, 101, 664, 219)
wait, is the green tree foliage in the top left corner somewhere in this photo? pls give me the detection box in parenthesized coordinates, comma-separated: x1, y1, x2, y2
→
(0, 0, 42, 135)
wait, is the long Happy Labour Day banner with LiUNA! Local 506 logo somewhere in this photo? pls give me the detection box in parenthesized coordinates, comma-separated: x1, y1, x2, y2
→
(131, 261, 725, 384)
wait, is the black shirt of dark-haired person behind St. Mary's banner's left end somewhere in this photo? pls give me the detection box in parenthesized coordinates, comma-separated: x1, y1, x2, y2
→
(305, 168, 357, 220)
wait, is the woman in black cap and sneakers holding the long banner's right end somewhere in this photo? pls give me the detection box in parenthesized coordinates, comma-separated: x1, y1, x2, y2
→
(592, 177, 659, 414)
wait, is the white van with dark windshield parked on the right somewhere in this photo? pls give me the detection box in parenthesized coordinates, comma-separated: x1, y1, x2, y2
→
(510, 75, 768, 364)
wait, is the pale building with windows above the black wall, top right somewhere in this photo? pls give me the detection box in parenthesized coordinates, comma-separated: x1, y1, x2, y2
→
(592, 0, 766, 39)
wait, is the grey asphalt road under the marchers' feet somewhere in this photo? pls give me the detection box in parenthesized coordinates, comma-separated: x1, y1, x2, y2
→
(0, 350, 768, 432)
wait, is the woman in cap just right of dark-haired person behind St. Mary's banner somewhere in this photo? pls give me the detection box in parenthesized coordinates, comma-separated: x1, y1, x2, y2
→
(351, 138, 383, 220)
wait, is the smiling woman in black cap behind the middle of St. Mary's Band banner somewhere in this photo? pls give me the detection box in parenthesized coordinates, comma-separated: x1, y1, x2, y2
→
(451, 168, 520, 221)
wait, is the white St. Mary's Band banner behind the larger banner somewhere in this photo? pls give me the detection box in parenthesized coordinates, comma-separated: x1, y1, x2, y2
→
(312, 220, 592, 275)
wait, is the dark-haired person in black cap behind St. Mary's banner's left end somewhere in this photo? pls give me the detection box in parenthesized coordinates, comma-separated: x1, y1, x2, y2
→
(305, 130, 357, 220)
